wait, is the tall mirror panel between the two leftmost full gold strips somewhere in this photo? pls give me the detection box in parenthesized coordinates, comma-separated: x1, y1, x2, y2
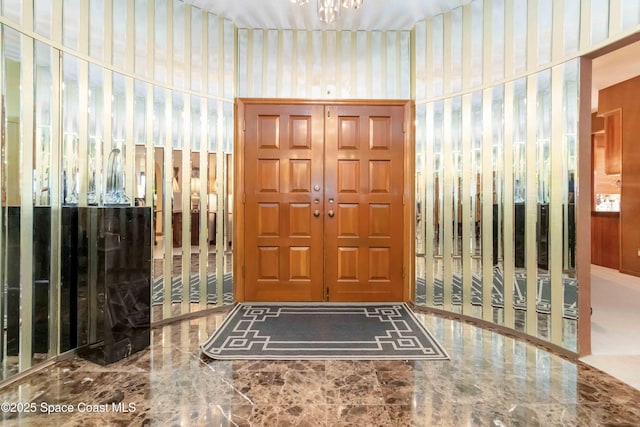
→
(31, 42, 57, 366)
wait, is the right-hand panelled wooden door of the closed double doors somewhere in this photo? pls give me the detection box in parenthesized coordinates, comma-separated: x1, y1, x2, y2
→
(325, 105, 404, 301)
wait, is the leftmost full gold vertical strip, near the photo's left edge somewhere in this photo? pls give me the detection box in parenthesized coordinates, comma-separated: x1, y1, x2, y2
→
(19, 29, 35, 372)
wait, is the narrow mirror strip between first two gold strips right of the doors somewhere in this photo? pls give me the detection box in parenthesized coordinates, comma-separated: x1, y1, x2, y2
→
(427, 101, 442, 307)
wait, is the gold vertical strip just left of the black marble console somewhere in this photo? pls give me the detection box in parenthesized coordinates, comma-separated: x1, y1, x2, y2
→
(48, 48, 62, 357)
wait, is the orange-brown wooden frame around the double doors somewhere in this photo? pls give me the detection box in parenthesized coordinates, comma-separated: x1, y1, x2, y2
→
(232, 98, 416, 302)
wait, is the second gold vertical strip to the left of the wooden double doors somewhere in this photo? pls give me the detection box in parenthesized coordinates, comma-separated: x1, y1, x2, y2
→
(198, 98, 209, 310)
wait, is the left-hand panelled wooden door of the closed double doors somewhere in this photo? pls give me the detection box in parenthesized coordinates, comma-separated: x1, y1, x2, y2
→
(244, 104, 324, 301)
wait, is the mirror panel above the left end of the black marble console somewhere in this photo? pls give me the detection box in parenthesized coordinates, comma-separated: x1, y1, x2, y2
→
(62, 54, 80, 205)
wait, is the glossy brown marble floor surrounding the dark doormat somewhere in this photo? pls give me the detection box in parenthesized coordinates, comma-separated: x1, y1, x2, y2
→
(0, 313, 640, 426)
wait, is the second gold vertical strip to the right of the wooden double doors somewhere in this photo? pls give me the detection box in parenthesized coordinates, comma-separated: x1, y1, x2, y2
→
(441, 98, 454, 311)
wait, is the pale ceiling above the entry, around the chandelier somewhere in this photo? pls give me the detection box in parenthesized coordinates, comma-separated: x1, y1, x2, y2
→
(185, 0, 471, 31)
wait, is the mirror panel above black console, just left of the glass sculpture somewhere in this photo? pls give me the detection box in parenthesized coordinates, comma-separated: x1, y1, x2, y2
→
(87, 64, 104, 206)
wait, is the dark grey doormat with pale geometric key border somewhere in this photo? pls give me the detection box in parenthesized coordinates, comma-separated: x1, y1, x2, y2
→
(200, 303, 449, 360)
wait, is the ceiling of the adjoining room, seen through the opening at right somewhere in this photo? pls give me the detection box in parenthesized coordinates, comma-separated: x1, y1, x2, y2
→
(591, 42, 640, 112)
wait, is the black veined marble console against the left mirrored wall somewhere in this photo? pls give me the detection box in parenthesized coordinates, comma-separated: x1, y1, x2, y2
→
(67, 206, 151, 365)
